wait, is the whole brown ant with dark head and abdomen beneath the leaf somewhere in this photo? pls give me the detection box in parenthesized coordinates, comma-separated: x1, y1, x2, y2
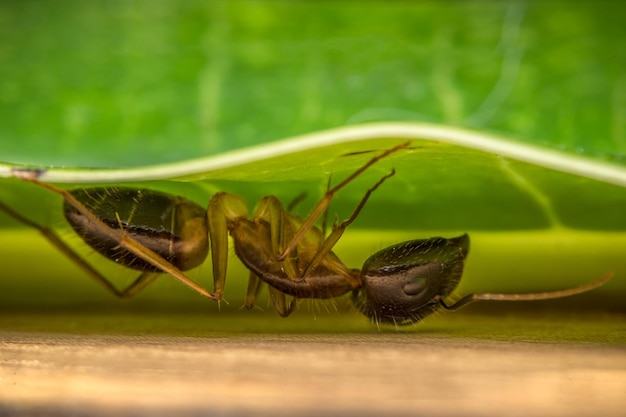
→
(0, 143, 611, 325)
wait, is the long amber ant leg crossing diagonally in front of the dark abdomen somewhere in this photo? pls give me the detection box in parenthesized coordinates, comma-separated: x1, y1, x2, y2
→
(6, 179, 216, 299)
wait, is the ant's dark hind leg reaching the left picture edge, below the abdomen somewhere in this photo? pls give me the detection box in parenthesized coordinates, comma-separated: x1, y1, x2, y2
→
(0, 198, 146, 298)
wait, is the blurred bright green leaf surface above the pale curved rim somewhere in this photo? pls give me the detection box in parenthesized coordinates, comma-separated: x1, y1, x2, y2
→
(0, 0, 626, 167)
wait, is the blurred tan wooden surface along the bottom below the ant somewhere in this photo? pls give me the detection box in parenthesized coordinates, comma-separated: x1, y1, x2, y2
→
(0, 331, 626, 417)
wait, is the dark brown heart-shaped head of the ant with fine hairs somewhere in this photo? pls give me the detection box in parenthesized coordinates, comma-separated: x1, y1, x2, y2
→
(352, 234, 469, 325)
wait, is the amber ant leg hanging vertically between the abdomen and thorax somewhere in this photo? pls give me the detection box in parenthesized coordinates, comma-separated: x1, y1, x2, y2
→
(207, 192, 248, 300)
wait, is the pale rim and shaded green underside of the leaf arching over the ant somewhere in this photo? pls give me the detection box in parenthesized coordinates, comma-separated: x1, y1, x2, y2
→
(0, 123, 626, 231)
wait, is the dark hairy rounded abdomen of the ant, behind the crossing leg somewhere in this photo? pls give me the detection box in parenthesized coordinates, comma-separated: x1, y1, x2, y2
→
(63, 187, 209, 272)
